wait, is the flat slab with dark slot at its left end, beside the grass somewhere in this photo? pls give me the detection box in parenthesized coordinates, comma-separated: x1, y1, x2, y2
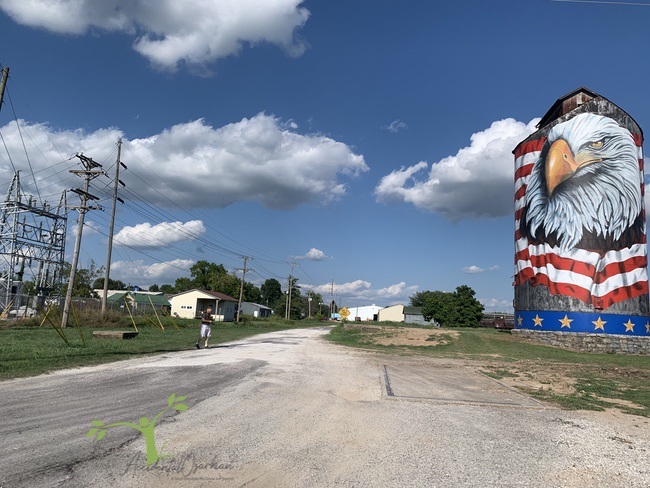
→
(382, 363, 544, 408)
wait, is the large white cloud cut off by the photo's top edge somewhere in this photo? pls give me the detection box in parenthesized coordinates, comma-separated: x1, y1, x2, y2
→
(0, 0, 309, 69)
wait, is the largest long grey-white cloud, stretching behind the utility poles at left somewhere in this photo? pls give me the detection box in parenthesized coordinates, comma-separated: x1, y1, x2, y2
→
(0, 113, 369, 213)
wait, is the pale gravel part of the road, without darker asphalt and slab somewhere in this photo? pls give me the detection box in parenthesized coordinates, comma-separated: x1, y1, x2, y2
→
(50, 328, 650, 488)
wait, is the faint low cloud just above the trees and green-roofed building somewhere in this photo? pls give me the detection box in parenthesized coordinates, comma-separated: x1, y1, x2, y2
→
(111, 259, 195, 285)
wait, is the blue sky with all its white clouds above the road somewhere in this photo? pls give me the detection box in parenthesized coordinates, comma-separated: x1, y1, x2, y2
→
(0, 0, 650, 311)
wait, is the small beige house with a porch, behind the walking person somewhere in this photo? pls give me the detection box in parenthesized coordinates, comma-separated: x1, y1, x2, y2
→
(169, 289, 237, 322)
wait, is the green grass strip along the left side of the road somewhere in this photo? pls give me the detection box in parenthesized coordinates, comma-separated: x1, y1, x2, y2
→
(0, 318, 321, 380)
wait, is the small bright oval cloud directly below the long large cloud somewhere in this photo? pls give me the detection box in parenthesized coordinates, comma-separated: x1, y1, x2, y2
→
(113, 220, 205, 249)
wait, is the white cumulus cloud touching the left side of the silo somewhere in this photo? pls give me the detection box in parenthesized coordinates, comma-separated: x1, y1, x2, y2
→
(375, 119, 539, 221)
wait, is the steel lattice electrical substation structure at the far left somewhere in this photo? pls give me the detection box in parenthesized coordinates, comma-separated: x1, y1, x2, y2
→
(0, 171, 67, 312)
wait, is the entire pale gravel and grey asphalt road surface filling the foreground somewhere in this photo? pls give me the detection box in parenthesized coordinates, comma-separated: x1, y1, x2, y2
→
(0, 328, 650, 488)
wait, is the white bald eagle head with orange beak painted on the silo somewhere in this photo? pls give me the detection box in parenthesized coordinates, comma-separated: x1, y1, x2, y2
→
(522, 113, 642, 251)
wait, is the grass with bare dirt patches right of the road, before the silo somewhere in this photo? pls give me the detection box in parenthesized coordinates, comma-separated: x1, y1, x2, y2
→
(328, 327, 650, 417)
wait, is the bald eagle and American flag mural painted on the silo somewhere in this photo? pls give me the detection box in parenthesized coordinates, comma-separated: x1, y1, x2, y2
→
(515, 113, 648, 309)
